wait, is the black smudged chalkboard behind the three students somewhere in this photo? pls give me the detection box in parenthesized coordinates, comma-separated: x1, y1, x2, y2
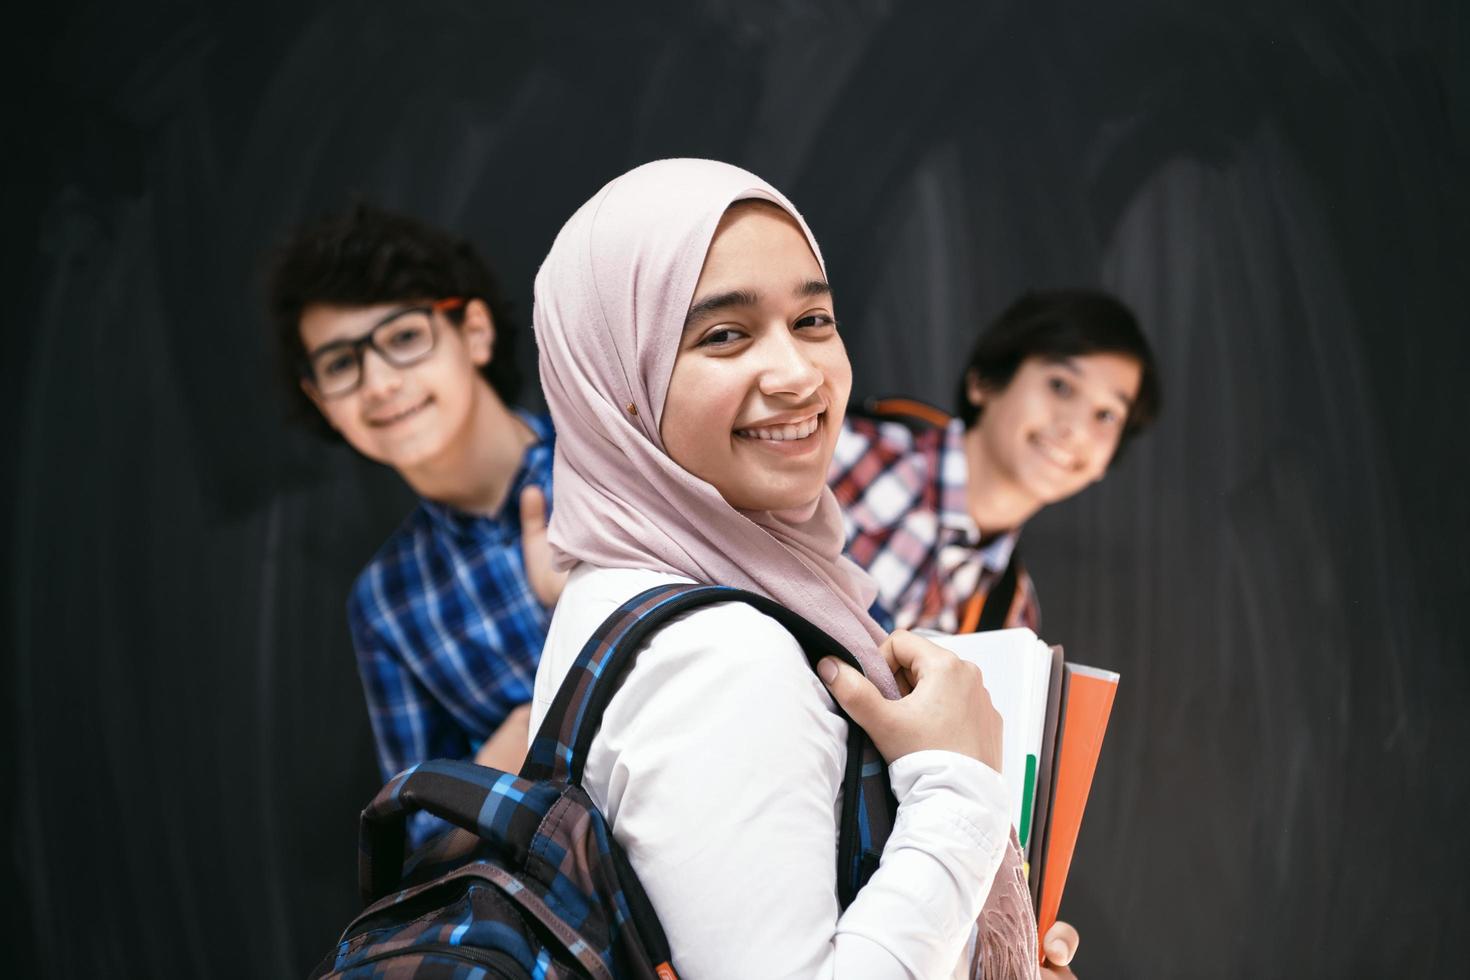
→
(0, 0, 1470, 979)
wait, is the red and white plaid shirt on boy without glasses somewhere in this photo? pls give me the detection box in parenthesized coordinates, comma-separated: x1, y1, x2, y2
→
(829, 416, 1041, 633)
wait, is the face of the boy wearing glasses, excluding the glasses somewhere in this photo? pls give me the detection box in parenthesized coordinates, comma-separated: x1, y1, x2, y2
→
(300, 300, 494, 473)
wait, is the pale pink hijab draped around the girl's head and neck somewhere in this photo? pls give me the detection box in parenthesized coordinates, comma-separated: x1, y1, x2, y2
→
(534, 160, 898, 698)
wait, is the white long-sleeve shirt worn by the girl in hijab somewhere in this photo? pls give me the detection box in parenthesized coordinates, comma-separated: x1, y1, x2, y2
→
(531, 564, 1010, 980)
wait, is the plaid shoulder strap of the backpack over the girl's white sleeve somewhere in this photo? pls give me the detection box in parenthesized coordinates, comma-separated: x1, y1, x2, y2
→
(520, 585, 897, 908)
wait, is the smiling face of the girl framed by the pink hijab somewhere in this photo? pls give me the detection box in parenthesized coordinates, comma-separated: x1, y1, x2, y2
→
(659, 203, 853, 511)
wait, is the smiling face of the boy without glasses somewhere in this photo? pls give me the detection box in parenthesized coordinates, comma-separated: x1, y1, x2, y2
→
(969, 354, 1142, 507)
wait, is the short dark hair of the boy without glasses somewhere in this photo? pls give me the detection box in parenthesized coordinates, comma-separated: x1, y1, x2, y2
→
(954, 289, 1163, 460)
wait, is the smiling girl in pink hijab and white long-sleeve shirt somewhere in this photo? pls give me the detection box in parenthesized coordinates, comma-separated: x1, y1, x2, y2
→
(531, 160, 1075, 980)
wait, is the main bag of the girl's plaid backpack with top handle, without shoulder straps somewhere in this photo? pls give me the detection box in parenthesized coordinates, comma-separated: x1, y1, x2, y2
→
(313, 760, 675, 980)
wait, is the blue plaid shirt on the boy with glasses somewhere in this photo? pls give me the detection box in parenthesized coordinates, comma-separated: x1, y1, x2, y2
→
(347, 413, 554, 843)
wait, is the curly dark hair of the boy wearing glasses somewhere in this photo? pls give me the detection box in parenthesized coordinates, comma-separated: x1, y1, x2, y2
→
(268, 203, 520, 439)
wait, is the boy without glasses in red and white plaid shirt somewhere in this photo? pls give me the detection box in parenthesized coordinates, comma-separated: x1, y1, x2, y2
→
(829, 289, 1160, 633)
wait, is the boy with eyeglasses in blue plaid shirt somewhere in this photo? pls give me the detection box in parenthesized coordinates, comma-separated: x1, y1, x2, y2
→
(269, 204, 560, 843)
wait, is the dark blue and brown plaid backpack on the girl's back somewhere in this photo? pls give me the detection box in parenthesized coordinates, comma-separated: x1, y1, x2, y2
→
(312, 585, 897, 980)
